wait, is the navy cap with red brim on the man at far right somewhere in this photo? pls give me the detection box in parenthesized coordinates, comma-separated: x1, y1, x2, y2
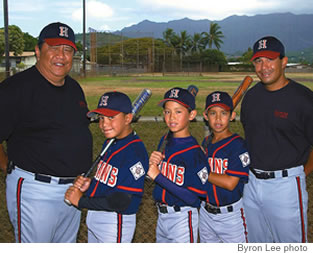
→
(251, 36, 285, 61)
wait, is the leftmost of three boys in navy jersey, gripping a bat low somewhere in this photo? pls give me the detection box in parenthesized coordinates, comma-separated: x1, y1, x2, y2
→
(65, 92, 149, 243)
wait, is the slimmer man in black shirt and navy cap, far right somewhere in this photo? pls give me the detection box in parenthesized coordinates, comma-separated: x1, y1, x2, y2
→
(241, 36, 313, 243)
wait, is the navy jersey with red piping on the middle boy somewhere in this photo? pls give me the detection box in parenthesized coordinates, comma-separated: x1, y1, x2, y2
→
(153, 136, 208, 207)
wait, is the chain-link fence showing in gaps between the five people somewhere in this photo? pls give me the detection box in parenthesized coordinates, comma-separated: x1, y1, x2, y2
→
(0, 121, 313, 243)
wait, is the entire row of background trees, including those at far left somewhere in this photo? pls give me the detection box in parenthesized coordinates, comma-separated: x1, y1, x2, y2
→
(0, 22, 251, 71)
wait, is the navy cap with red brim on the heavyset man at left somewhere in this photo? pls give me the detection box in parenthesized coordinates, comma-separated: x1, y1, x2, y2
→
(38, 22, 77, 51)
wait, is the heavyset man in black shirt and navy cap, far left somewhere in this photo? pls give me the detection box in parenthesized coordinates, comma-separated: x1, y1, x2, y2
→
(0, 23, 92, 242)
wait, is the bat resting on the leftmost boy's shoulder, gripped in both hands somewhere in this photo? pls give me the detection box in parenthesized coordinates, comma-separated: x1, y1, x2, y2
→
(64, 89, 152, 205)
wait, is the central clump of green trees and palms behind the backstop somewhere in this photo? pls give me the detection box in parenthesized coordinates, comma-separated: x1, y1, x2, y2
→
(91, 22, 233, 71)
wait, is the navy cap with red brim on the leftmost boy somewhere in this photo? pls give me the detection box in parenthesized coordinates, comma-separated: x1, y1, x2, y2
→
(87, 91, 132, 118)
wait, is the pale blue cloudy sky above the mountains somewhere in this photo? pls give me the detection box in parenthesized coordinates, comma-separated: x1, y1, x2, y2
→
(0, 0, 313, 37)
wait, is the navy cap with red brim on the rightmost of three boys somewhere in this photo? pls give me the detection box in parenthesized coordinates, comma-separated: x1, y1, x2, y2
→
(205, 91, 234, 111)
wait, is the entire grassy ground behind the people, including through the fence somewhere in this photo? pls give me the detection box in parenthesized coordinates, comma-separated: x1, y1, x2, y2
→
(0, 73, 313, 242)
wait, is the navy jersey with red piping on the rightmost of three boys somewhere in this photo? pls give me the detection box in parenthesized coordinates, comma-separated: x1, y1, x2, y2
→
(203, 134, 250, 206)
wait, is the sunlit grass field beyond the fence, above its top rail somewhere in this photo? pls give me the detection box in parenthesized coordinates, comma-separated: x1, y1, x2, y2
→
(80, 73, 313, 116)
